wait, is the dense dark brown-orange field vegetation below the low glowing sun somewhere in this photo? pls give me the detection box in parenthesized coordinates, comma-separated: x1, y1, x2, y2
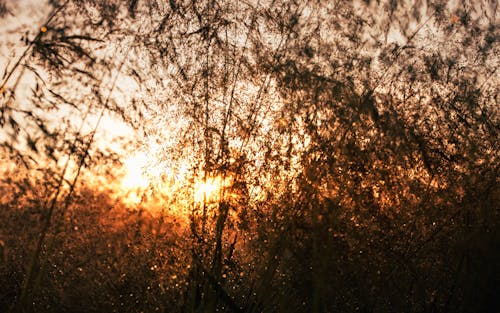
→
(0, 163, 500, 312)
